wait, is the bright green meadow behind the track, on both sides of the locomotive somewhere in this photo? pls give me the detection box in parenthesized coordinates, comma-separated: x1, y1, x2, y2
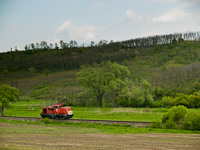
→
(4, 100, 200, 122)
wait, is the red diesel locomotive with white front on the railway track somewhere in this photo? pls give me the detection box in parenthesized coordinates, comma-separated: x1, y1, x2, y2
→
(40, 103, 73, 119)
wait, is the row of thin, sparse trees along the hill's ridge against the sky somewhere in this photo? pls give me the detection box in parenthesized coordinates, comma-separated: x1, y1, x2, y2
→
(21, 32, 200, 50)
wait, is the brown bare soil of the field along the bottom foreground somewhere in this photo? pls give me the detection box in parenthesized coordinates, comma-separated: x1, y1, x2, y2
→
(0, 123, 200, 150)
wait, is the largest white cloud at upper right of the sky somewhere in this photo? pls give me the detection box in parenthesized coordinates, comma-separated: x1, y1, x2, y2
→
(152, 7, 193, 22)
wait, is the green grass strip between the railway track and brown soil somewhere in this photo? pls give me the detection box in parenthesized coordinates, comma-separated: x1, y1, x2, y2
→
(0, 119, 200, 134)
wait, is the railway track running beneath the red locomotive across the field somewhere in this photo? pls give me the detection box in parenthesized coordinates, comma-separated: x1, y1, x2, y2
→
(0, 116, 151, 127)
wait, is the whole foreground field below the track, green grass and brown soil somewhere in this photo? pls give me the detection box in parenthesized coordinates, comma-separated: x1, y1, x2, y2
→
(0, 119, 200, 150)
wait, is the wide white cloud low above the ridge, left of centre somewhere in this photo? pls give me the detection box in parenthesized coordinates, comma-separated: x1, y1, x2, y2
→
(56, 20, 106, 42)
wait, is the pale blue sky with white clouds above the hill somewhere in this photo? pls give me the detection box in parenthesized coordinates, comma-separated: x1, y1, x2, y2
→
(0, 0, 200, 52)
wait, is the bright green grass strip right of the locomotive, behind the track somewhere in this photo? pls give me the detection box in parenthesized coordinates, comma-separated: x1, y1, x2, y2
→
(72, 107, 168, 122)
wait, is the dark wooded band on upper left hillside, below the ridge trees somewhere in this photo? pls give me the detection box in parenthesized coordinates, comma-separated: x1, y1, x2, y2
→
(0, 45, 135, 73)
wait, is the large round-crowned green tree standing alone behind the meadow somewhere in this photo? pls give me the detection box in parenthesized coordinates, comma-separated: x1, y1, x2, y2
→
(78, 61, 130, 107)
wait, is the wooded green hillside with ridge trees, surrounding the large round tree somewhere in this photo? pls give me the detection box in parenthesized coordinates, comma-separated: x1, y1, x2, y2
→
(0, 32, 200, 107)
